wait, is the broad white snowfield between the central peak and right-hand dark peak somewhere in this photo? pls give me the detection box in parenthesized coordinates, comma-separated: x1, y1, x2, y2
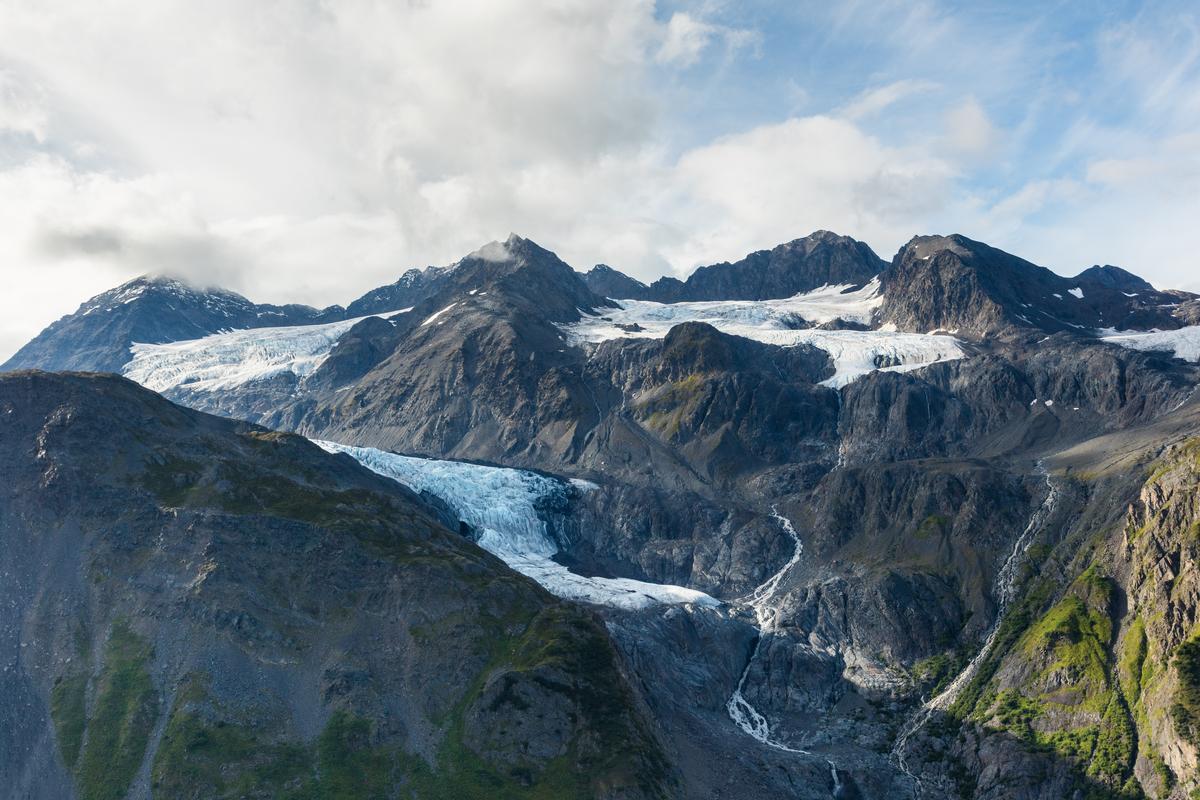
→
(562, 279, 965, 389)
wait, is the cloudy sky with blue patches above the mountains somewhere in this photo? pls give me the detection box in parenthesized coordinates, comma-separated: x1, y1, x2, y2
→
(0, 0, 1200, 360)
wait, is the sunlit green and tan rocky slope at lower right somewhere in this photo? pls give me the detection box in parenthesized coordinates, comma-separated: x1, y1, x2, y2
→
(883, 429, 1200, 800)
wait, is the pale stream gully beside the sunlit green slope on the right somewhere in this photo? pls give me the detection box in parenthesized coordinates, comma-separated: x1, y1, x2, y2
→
(892, 461, 1058, 798)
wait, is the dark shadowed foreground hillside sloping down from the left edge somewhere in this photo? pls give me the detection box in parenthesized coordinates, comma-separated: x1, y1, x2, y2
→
(0, 373, 676, 798)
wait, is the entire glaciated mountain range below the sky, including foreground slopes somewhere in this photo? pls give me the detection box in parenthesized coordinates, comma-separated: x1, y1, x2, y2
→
(0, 231, 1200, 800)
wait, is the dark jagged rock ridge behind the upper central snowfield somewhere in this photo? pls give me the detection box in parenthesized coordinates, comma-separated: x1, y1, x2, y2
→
(584, 230, 886, 302)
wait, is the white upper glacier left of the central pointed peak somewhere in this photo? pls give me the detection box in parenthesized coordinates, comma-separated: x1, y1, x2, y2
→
(121, 316, 408, 392)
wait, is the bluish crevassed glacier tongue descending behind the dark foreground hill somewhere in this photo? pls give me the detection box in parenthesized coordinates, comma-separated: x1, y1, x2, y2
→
(316, 440, 720, 609)
